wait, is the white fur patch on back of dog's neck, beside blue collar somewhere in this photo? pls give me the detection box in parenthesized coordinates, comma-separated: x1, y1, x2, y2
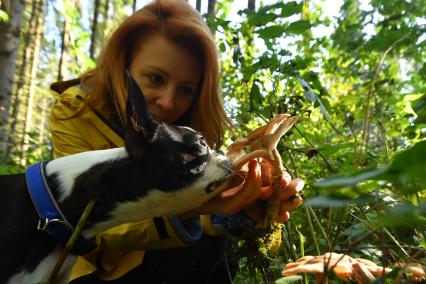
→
(46, 147, 128, 202)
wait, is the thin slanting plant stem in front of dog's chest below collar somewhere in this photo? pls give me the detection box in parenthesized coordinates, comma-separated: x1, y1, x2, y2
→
(47, 198, 97, 284)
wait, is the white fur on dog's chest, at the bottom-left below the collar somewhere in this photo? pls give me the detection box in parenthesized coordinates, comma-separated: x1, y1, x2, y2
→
(7, 247, 77, 284)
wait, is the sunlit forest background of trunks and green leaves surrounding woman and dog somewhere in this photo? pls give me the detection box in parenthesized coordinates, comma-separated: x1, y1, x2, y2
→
(0, 0, 426, 283)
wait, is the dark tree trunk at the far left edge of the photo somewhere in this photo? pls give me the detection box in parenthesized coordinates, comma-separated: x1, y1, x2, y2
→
(0, 0, 25, 155)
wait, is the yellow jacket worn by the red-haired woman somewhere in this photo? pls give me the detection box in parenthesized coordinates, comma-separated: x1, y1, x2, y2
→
(48, 80, 217, 281)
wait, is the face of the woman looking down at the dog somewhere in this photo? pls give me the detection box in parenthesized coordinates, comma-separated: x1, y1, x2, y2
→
(130, 34, 201, 123)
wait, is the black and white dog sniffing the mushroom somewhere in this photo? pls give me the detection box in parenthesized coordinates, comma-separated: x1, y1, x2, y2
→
(0, 75, 232, 283)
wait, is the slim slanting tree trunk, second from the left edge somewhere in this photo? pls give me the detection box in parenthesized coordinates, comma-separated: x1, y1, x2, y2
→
(4, 1, 39, 162)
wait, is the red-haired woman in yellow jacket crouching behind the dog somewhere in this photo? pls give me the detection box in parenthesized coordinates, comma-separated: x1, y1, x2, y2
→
(49, 0, 303, 283)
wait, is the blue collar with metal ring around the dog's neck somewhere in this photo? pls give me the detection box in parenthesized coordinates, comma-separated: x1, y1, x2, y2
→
(25, 161, 92, 254)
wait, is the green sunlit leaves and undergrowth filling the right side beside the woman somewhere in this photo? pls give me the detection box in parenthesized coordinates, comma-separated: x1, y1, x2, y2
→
(209, 0, 426, 283)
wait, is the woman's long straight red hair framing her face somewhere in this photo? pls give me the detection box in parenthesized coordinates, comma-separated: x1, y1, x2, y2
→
(82, 0, 230, 148)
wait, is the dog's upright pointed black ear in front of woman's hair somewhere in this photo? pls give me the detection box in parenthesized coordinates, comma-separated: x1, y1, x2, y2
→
(125, 70, 158, 157)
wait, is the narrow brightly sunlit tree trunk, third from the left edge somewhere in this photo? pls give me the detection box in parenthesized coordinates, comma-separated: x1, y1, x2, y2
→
(20, 0, 44, 167)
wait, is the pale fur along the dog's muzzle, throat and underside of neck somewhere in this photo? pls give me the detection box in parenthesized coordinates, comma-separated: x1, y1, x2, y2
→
(83, 153, 229, 238)
